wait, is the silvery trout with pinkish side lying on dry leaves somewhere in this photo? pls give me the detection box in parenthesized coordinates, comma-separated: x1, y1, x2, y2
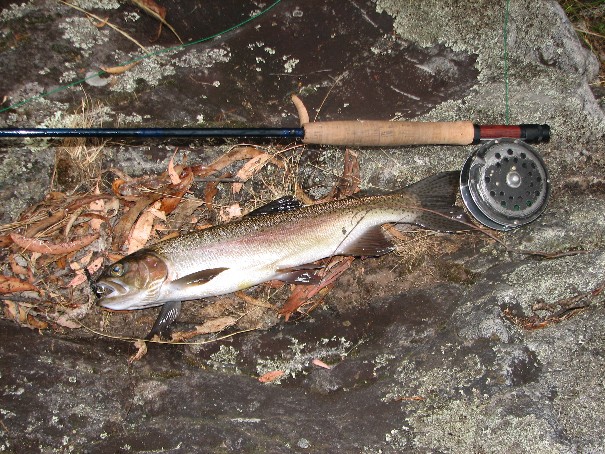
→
(93, 172, 469, 337)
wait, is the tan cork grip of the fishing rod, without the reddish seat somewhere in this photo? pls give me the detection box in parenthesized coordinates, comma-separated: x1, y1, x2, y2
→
(302, 121, 475, 146)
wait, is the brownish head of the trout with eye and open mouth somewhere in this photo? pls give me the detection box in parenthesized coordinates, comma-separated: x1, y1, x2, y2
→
(93, 249, 168, 311)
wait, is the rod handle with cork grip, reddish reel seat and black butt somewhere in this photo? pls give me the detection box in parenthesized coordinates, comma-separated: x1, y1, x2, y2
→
(302, 120, 550, 146)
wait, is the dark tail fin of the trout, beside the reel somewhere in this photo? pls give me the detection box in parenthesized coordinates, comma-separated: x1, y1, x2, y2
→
(405, 171, 472, 232)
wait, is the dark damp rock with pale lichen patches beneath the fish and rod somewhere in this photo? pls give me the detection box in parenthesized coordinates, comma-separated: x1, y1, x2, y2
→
(0, 0, 605, 453)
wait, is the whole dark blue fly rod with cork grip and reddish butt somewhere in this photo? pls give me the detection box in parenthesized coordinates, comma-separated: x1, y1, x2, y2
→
(0, 96, 550, 146)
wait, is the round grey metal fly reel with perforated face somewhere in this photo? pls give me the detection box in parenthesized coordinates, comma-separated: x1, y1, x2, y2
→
(460, 139, 550, 231)
